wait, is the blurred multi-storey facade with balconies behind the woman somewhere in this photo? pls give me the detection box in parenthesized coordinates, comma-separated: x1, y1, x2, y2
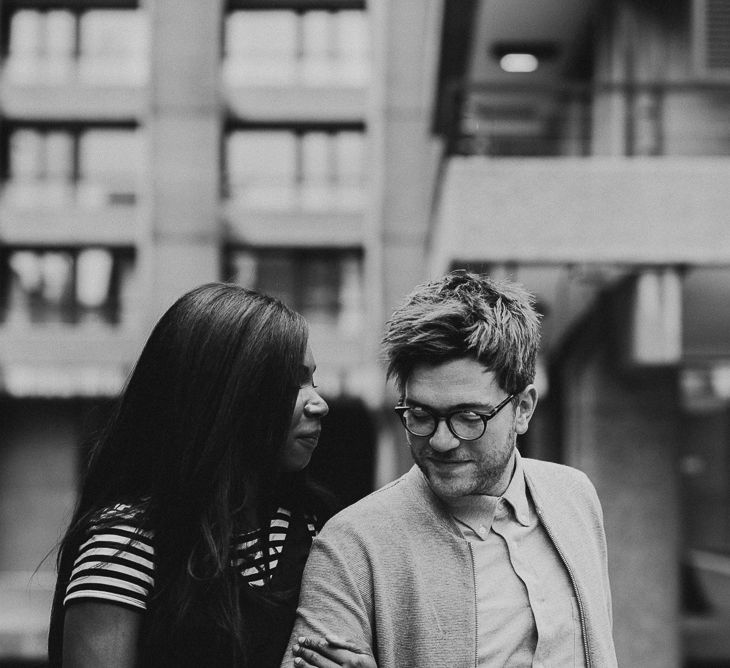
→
(0, 0, 377, 660)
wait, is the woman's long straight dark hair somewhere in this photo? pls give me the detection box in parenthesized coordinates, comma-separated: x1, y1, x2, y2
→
(49, 283, 322, 665)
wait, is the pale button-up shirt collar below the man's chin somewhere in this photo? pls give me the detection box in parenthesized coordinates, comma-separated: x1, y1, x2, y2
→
(448, 448, 530, 533)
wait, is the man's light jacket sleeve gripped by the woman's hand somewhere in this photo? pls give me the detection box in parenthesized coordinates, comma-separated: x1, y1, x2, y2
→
(281, 521, 375, 668)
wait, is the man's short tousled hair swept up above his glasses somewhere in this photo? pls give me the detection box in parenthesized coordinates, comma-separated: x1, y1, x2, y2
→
(383, 270, 540, 394)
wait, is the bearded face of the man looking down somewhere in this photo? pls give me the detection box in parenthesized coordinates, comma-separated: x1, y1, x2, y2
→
(403, 358, 537, 501)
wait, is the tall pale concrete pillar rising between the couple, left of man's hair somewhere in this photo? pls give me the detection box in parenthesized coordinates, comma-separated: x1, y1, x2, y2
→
(366, 0, 443, 484)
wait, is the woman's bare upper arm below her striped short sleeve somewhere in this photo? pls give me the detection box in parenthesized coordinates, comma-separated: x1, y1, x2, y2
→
(63, 601, 144, 668)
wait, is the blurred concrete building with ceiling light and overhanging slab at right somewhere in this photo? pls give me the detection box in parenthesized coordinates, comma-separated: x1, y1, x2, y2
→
(424, 0, 730, 667)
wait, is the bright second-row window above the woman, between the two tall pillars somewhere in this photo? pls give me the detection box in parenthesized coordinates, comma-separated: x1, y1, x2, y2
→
(225, 129, 365, 211)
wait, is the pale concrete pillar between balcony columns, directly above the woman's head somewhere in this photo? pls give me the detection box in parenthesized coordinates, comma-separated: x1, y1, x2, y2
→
(142, 0, 223, 320)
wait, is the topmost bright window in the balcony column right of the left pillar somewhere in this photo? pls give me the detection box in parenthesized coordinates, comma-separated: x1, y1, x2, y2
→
(223, 10, 369, 86)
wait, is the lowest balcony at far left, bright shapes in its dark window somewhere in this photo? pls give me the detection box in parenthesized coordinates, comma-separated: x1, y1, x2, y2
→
(0, 242, 144, 397)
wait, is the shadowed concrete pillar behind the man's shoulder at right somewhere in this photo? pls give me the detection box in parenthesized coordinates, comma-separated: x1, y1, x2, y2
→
(560, 293, 681, 668)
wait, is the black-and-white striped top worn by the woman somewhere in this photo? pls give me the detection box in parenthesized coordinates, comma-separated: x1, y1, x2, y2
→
(64, 504, 317, 610)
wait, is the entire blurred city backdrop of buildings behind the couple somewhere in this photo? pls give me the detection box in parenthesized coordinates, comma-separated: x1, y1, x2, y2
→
(0, 0, 730, 668)
